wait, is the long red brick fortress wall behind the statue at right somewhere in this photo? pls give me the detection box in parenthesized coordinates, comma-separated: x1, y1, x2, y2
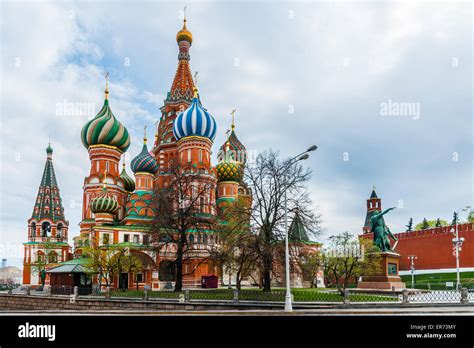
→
(360, 223, 474, 271)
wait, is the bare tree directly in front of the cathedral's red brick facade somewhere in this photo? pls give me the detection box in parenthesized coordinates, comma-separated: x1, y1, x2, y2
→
(150, 165, 215, 292)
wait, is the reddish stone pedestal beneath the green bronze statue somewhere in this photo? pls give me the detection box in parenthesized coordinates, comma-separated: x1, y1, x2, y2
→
(357, 251, 406, 290)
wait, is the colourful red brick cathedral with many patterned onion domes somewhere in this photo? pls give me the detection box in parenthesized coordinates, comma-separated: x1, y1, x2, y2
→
(23, 19, 251, 290)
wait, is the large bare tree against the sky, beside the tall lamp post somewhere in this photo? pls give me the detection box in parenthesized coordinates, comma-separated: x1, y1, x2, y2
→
(245, 150, 320, 291)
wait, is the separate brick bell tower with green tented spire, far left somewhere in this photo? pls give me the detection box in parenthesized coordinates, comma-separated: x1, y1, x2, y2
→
(23, 144, 70, 286)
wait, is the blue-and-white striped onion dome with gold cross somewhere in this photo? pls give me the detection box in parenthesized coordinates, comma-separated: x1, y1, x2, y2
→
(173, 88, 217, 140)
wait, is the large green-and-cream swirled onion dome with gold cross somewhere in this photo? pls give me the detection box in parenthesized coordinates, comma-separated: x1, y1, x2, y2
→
(81, 75, 130, 152)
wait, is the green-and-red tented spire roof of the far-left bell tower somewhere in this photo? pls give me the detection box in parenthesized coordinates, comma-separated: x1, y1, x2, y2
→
(31, 143, 65, 222)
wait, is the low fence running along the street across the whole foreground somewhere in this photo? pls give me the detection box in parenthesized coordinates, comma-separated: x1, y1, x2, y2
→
(4, 286, 474, 304)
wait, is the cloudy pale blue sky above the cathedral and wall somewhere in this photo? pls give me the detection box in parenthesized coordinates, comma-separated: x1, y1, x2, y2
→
(0, 0, 474, 266)
